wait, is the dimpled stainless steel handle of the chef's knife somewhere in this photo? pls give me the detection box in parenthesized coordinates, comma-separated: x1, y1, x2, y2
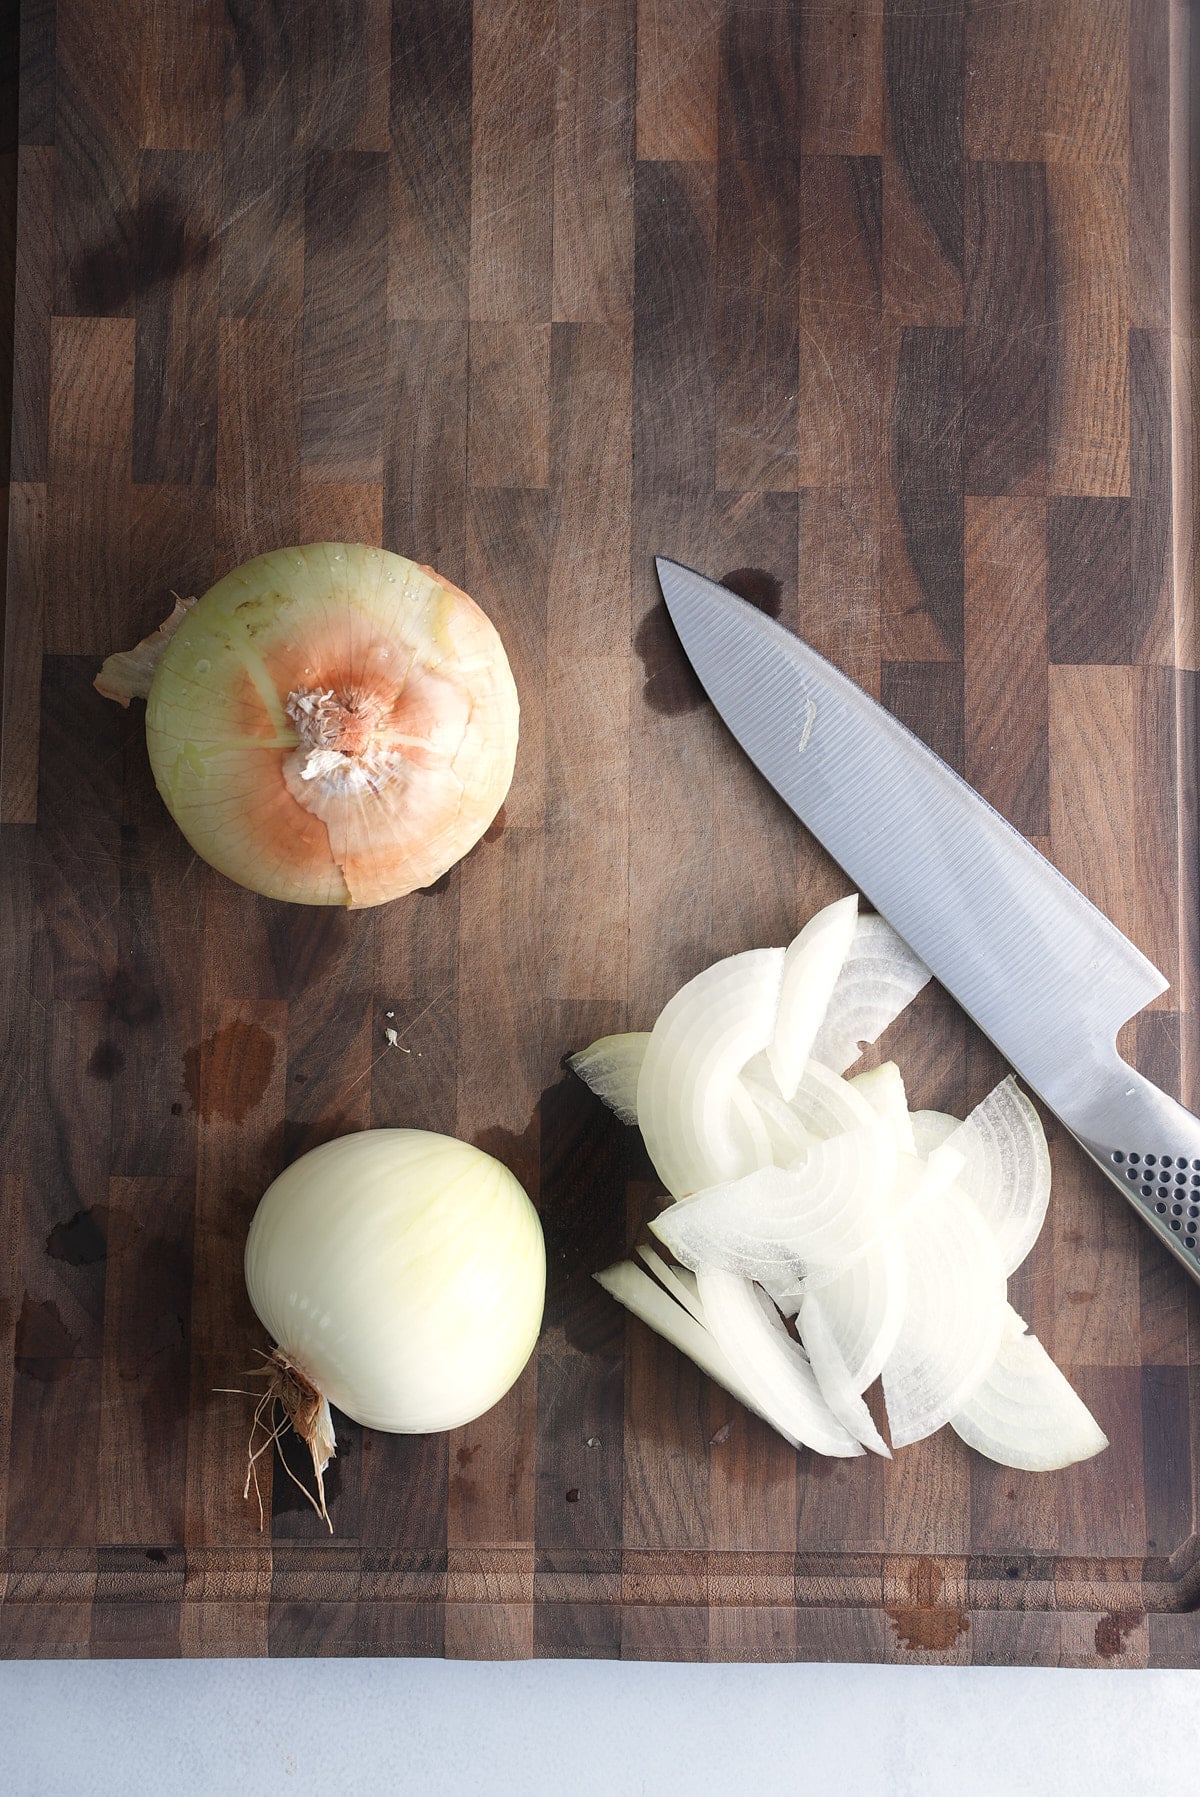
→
(1063, 1049, 1200, 1281)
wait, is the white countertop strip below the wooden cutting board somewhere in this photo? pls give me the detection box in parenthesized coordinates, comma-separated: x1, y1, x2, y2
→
(0, 1660, 1200, 1797)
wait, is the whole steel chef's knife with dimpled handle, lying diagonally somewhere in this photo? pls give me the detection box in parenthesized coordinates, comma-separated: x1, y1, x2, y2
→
(657, 557, 1200, 1279)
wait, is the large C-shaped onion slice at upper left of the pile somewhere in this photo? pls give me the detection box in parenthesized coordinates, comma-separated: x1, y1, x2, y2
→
(636, 949, 783, 1199)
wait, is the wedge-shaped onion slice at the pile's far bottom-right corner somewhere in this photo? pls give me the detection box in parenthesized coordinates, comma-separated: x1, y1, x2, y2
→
(950, 1305, 1108, 1472)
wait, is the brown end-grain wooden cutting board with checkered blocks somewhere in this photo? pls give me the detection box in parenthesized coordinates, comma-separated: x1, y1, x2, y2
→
(0, 0, 1200, 1666)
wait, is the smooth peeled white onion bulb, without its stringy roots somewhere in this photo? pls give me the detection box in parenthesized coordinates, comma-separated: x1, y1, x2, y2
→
(246, 1129, 546, 1434)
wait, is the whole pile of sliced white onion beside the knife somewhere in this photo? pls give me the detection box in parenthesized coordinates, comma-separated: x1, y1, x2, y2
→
(582, 899, 1107, 1470)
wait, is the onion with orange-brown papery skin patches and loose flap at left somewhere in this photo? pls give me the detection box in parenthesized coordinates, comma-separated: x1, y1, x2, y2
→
(95, 543, 517, 906)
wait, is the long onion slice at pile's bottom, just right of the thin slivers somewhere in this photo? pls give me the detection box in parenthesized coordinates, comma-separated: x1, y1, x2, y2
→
(697, 1272, 862, 1459)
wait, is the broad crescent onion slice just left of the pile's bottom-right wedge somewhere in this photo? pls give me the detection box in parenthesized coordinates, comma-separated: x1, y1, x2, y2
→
(884, 1188, 1006, 1448)
